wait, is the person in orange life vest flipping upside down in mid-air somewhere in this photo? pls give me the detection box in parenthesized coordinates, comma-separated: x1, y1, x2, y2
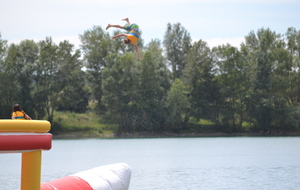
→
(106, 18, 141, 59)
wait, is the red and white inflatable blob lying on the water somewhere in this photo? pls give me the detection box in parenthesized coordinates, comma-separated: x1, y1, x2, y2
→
(41, 163, 131, 190)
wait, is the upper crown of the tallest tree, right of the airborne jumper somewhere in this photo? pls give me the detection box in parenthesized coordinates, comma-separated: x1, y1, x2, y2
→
(164, 23, 192, 80)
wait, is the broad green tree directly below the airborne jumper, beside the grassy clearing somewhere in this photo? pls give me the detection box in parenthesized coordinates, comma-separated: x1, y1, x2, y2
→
(103, 53, 138, 133)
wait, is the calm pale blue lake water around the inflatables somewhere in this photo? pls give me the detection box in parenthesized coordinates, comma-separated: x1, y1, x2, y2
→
(0, 137, 300, 190)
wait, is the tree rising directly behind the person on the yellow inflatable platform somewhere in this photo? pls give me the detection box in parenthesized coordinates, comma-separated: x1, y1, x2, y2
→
(3, 40, 38, 118)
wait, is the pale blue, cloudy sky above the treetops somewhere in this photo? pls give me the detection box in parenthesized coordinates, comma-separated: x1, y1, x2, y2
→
(0, 0, 300, 48)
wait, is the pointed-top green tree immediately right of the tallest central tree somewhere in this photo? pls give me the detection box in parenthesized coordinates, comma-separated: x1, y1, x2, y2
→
(184, 40, 220, 124)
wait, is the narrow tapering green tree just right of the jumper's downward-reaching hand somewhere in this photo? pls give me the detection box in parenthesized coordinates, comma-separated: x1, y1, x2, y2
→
(137, 51, 166, 132)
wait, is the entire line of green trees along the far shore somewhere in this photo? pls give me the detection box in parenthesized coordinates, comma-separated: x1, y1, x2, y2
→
(0, 23, 300, 133)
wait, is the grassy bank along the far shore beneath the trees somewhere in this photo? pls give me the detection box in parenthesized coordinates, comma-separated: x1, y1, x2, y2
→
(50, 112, 300, 138)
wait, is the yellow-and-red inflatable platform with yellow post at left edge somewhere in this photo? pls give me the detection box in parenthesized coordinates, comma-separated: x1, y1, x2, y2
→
(0, 119, 52, 190)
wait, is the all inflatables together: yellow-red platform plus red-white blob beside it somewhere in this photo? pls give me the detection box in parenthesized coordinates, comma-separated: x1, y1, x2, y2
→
(0, 119, 131, 190)
